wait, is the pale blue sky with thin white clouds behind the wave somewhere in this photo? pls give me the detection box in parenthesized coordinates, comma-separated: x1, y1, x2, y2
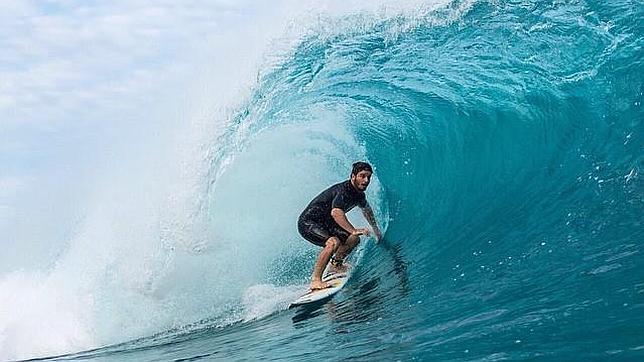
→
(0, 0, 266, 272)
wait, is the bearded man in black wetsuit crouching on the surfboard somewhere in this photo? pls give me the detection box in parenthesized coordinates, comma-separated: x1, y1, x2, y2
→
(297, 162, 382, 290)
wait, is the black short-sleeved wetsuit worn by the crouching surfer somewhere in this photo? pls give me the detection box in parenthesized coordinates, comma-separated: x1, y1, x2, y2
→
(297, 180, 367, 247)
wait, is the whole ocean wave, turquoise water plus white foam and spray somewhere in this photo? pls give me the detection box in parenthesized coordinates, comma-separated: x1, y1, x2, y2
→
(0, 0, 644, 361)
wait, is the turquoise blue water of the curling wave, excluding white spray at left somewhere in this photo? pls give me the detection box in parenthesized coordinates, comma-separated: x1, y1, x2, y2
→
(15, 0, 644, 361)
